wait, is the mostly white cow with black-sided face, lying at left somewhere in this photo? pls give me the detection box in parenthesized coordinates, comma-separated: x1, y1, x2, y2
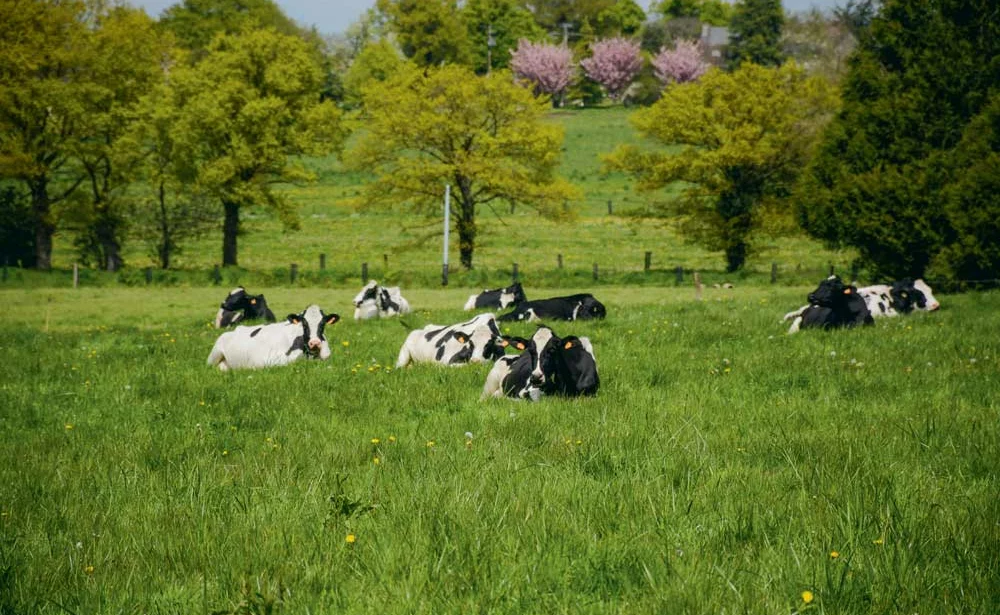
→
(208, 305, 340, 371)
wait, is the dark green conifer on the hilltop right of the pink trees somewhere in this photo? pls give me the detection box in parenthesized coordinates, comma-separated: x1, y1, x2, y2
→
(726, 0, 785, 70)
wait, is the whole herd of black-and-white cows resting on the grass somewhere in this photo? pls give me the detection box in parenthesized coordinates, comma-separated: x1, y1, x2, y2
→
(208, 276, 940, 401)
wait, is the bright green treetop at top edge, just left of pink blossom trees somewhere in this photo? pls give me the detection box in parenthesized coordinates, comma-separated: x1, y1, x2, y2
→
(462, 0, 545, 74)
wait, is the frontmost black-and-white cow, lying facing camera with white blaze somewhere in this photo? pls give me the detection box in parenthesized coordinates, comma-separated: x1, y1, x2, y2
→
(480, 326, 601, 401)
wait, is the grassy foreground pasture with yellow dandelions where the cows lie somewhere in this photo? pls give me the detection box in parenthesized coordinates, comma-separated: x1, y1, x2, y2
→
(0, 286, 1000, 615)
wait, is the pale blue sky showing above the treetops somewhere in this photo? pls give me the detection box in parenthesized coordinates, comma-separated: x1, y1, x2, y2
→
(131, 0, 846, 34)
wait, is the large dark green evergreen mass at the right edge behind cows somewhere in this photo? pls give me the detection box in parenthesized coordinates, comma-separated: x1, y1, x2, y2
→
(800, 0, 1000, 277)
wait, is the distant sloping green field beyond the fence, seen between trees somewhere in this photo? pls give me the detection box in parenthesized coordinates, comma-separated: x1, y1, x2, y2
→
(37, 107, 853, 286)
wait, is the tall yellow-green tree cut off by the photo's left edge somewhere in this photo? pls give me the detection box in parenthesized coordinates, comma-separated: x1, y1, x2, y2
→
(0, 0, 93, 269)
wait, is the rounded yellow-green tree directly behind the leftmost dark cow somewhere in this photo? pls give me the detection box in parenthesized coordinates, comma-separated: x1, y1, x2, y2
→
(163, 30, 346, 265)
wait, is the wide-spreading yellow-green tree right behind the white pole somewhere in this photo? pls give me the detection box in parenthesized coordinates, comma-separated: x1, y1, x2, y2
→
(346, 65, 576, 269)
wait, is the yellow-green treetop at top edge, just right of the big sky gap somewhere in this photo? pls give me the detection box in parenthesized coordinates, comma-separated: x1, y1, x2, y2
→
(376, 0, 472, 66)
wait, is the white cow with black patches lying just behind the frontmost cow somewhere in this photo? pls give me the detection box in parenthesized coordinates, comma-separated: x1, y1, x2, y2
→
(396, 314, 503, 367)
